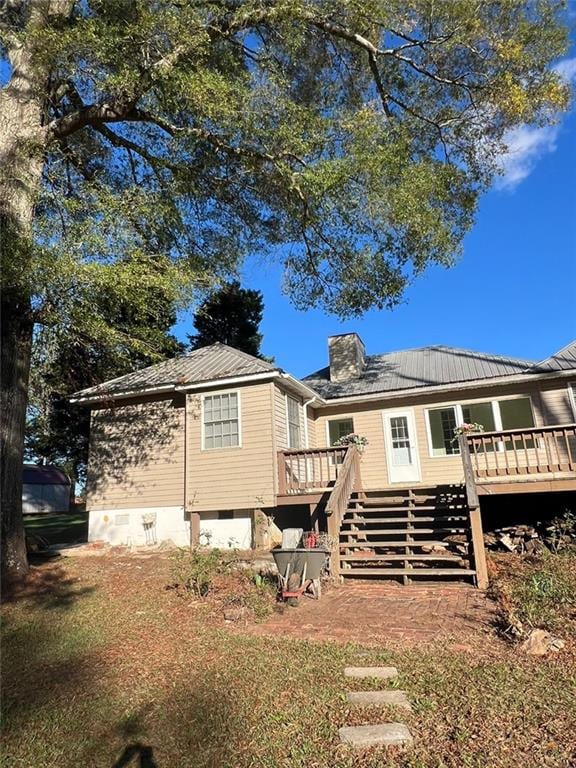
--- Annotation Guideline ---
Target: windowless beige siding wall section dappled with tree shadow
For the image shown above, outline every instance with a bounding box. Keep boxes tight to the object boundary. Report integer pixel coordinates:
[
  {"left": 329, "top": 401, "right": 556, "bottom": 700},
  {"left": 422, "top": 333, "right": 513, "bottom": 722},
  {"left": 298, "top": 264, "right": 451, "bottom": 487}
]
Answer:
[{"left": 86, "top": 396, "right": 184, "bottom": 510}]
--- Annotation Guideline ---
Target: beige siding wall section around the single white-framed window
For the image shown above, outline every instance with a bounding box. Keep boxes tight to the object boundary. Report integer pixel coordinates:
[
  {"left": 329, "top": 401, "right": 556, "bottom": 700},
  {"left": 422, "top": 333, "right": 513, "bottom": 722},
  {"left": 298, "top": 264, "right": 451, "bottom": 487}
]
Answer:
[{"left": 187, "top": 383, "right": 274, "bottom": 512}]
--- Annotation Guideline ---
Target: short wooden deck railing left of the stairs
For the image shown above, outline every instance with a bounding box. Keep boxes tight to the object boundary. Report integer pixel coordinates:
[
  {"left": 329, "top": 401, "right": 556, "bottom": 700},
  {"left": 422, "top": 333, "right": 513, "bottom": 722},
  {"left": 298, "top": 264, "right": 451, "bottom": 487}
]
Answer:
[{"left": 278, "top": 446, "right": 347, "bottom": 496}]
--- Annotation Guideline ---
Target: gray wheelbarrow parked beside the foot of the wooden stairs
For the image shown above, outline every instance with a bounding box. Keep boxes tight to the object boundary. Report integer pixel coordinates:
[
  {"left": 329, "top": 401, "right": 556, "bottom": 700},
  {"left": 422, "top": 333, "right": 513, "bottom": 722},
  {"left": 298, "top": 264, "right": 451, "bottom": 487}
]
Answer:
[{"left": 272, "top": 548, "right": 328, "bottom": 605}]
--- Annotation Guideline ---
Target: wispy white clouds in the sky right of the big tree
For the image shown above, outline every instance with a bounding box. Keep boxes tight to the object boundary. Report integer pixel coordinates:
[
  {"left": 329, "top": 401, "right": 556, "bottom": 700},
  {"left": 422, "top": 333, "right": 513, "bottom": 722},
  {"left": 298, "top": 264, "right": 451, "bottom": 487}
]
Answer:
[{"left": 495, "top": 58, "right": 576, "bottom": 190}]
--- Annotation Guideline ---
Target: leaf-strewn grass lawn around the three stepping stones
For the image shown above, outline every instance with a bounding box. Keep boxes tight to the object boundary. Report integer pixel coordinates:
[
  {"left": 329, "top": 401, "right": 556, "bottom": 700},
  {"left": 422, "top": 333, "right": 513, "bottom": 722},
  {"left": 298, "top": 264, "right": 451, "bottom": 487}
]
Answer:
[{"left": 0, "top": 555, "right": 576, "bottom": 768}]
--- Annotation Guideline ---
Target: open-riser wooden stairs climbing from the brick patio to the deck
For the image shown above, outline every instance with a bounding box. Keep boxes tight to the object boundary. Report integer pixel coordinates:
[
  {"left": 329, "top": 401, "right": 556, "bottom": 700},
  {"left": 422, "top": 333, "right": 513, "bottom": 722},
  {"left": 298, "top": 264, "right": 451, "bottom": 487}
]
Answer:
[{"left": 338, "top": 486, "right": 477, "bottom": 584}]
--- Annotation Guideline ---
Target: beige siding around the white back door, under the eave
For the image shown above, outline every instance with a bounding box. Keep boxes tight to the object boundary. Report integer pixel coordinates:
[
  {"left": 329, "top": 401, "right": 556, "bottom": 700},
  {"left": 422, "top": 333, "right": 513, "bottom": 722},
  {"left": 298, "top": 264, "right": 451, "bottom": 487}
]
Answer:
[{"left": 315, "top": 382, "right": 572, "bottom": 490}]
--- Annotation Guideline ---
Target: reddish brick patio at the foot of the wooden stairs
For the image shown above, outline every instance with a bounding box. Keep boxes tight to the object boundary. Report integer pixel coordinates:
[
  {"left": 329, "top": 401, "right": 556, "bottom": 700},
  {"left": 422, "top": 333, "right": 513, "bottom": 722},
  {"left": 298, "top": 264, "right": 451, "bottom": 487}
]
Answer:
[{"left": 243, "top": 582, "right": 492, "bottom": 649}]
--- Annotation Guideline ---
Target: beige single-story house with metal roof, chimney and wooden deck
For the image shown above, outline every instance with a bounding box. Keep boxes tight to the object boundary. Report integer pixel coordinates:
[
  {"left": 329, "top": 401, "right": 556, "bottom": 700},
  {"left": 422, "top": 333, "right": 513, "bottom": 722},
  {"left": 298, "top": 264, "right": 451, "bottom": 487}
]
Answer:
[{"left": 74, "top": 333, "right": 576, "bottom": 585}]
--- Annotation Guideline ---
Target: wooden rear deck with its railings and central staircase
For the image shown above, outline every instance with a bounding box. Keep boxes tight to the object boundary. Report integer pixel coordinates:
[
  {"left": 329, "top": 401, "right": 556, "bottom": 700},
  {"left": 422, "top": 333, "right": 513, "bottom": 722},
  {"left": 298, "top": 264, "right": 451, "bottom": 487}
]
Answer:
[{"left": 277, "top": 424, "right": 576, "bottom": 588}]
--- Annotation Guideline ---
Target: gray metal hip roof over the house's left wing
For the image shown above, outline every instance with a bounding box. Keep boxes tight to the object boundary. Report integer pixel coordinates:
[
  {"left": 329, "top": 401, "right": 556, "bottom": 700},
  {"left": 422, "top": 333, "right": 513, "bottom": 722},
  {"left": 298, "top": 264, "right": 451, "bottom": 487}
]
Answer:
[{"left": 74, "top": 342, "right": 279, "bottom": 398}]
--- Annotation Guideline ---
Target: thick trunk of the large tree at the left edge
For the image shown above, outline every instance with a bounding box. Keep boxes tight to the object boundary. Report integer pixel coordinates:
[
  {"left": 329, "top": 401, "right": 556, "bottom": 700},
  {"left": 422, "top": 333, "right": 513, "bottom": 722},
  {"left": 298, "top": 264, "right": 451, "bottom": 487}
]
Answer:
[{"left": 0, "top": 0, "right": 49, "bottom": 581}]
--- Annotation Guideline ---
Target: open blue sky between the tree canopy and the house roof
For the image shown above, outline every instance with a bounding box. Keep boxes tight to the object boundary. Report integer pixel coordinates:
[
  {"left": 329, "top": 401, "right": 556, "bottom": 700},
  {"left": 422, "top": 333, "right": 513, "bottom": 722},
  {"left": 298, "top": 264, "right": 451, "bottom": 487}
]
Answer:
[{"left": 176, "top": 59, "right": 576, "bottom": 376}]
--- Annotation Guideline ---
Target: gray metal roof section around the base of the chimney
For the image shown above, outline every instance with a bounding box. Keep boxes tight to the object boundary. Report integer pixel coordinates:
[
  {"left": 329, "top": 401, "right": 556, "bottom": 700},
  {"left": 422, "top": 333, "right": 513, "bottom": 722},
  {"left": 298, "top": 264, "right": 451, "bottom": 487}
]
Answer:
[{"left": 302, "top": 346, "right": 533, "bottom": 399}]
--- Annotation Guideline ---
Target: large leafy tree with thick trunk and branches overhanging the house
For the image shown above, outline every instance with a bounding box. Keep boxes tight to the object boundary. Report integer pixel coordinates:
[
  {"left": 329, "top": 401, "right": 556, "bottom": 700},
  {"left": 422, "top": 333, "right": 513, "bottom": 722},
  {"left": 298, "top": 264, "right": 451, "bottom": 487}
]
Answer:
[{"left": 0, "top": 0, "right": 567, "bottom": 576}]
